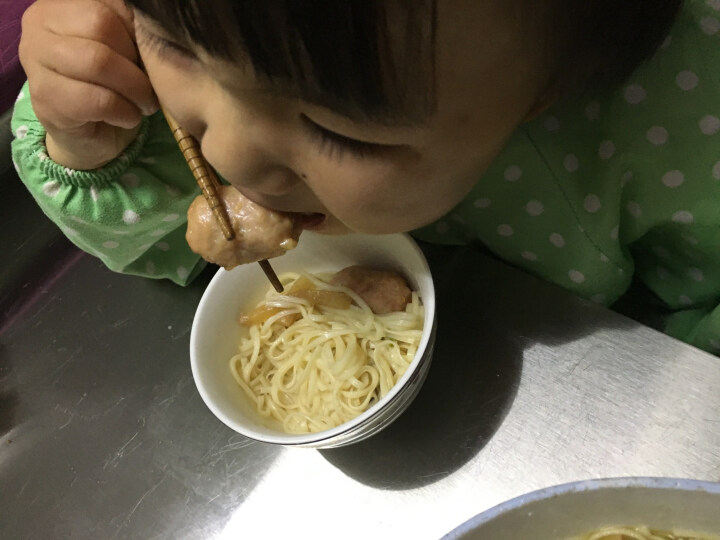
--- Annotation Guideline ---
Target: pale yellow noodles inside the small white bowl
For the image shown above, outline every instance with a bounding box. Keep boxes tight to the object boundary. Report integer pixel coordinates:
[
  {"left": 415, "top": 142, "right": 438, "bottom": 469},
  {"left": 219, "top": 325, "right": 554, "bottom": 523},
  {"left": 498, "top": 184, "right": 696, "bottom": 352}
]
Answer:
[{"left": 230, "top": 273, "right": 424, "bottom": 433}]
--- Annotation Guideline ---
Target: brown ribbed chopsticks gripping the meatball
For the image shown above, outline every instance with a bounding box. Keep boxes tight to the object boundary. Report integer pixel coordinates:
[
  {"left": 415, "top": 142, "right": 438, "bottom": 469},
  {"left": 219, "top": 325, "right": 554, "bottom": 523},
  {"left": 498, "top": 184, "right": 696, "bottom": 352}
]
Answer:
[{"left": 163, "top": 111, "right": 283, "bottom": 293}]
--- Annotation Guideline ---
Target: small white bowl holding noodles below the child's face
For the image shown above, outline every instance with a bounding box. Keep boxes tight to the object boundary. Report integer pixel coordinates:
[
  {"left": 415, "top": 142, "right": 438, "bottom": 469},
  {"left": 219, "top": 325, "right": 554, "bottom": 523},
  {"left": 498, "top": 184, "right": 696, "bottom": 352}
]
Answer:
[{"left": 190, "top": 232, "right": 435, "bottom": 448}]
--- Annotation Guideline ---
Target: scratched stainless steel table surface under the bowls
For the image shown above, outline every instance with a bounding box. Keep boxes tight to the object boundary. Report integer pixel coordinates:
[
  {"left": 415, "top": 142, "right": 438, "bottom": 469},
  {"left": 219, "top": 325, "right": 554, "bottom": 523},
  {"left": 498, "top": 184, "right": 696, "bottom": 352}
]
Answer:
[{"left": 0, "top": 167, "right": 720, "bottom": 539}]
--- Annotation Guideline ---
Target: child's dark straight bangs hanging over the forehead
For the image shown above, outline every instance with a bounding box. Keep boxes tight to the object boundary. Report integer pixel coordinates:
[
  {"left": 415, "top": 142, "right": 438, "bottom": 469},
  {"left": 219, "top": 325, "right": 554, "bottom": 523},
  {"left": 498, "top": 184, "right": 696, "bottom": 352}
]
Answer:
[{"left": 127, "top": 0, "right": 436, "bottom": 124}]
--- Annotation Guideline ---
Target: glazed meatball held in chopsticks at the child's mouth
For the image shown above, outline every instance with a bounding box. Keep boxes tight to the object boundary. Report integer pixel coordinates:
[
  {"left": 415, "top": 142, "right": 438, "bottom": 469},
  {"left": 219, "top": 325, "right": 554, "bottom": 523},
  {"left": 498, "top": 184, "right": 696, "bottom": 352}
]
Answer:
[{"left": 185, "top": 186, "right": 302, "bottom": 270}]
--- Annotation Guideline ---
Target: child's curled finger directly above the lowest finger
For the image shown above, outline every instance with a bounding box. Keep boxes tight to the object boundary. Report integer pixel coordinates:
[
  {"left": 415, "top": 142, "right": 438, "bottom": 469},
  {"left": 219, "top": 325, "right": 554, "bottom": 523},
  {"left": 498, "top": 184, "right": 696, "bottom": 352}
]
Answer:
[{"left": 42, "top": 33, "right": 157, "bottom": 114}]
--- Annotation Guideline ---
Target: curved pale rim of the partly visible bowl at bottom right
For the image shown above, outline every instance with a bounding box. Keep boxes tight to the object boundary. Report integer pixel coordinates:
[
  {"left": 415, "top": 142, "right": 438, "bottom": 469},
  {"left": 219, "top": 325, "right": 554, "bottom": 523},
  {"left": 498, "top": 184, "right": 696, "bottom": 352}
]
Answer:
[{"left": 441, "top": 476, "right": 720, "bottom": 540}]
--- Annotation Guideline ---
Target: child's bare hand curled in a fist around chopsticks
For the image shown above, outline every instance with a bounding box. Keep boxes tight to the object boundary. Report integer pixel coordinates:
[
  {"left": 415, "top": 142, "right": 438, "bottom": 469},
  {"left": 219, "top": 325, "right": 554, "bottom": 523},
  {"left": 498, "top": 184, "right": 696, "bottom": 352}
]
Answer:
[{"left": 20, "top": 0, "right": 157, "bottom": 169}]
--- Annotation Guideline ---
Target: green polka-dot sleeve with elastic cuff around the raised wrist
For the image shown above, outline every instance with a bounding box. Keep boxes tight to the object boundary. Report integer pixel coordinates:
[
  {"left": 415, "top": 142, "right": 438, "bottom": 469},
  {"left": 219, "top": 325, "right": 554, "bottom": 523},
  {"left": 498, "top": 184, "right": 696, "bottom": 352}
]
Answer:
[{"left": 11, "top": 83, "right": 204, "bottom": 285}]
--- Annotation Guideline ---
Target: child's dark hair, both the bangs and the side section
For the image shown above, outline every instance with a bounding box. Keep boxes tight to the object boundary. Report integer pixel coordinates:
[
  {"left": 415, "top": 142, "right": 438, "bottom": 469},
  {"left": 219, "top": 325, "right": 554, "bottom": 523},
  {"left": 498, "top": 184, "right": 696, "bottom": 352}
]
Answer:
[{"left": 126, "top": 0, "right": 682, "bottom": 118}]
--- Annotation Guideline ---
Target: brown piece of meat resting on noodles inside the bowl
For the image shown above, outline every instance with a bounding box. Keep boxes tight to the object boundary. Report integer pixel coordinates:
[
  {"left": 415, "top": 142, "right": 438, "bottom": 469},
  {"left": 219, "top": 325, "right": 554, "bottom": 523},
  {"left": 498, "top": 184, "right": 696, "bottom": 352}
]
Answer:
[{"left": 330, "top": 266, "right": 412, "bottom": 314}]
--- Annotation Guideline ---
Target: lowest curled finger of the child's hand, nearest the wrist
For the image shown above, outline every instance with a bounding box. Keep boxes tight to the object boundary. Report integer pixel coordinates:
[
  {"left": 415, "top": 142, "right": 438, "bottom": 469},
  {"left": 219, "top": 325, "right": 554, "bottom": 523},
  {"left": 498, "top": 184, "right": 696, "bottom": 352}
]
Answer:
[{"left": 30, "top": 72, "right": 142, "bottom": 131}]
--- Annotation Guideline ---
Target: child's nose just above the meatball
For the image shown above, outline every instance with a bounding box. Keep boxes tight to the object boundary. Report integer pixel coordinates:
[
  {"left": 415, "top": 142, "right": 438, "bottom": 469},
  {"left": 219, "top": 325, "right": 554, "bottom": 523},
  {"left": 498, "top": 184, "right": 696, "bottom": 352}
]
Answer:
[{"left": 201, "top": 119, "right": 301, "bottom": 196}]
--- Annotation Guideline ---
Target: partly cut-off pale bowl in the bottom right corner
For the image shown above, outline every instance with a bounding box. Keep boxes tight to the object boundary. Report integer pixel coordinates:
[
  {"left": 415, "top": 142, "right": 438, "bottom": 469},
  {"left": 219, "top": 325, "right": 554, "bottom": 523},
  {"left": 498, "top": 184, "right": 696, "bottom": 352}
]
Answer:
[{"left": 443, "top": 477, "right": 720, "bottom": 540}]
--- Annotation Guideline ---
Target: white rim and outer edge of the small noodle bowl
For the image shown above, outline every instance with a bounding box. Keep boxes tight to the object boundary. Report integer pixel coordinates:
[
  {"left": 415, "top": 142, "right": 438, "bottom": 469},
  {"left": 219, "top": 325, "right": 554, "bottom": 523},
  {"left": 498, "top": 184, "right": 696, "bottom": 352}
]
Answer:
[{"left": 190, "top": 233, "right": 437, "bottom": 448}]
